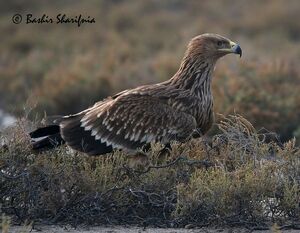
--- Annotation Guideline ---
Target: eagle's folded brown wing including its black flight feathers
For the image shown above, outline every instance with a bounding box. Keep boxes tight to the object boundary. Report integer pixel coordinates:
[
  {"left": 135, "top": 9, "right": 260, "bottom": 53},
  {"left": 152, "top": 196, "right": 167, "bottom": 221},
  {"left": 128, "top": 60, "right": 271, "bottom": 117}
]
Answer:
[{"left": 61, "top": 93, "right": 196, "bottom": 155}]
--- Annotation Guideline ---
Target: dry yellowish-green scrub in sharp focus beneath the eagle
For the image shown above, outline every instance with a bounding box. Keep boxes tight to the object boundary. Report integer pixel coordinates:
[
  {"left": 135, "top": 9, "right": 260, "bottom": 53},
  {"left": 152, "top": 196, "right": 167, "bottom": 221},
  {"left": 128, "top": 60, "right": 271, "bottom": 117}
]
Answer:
[{"left": 0, "top": 115, "right": 300, "bottom": 228}]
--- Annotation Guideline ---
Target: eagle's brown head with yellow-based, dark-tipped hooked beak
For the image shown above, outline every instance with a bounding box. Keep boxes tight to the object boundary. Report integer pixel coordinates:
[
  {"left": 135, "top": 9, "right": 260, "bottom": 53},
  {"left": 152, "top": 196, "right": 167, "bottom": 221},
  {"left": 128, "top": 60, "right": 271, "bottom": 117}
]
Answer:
[{"left": 186, "top": 33, "right": 242, "bottom": 61}]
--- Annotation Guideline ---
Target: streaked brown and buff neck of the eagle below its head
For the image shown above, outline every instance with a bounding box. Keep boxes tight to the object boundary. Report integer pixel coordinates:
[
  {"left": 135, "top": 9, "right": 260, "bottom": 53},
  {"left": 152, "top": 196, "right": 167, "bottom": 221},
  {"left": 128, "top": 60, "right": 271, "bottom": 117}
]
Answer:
[{"left": 169, "top": 56, "right": 215, "bottom": 97}]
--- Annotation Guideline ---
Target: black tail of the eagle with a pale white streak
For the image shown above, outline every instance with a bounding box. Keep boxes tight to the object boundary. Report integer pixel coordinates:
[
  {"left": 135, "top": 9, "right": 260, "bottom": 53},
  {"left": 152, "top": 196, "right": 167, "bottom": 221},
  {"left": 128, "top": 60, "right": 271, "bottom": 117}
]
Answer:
[{"left": 29, "top": 125, "right": 65, "bottom": 150}]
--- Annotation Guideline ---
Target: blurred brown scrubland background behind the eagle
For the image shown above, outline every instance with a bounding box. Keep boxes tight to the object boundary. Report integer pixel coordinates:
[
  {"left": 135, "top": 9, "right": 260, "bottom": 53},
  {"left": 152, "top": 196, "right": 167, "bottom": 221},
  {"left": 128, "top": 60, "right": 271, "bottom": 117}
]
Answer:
[{"left": 0, "top": 0, "right": 300, "bottom": 140}]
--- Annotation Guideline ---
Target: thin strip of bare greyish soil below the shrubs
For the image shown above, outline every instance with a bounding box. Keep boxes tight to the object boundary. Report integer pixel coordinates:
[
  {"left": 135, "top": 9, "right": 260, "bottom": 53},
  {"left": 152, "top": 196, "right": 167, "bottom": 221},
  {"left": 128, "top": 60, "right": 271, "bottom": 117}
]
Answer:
[{"left": 8, "top": 226, "right": 299, "bottom": 233}]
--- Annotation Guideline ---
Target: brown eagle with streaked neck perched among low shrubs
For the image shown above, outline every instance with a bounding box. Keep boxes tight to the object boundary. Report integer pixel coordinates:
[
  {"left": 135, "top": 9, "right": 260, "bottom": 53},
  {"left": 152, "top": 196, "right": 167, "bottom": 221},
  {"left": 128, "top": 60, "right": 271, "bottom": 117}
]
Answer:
[{"left": 30, "top": 33, "right": 242, "bottom": 156}]
